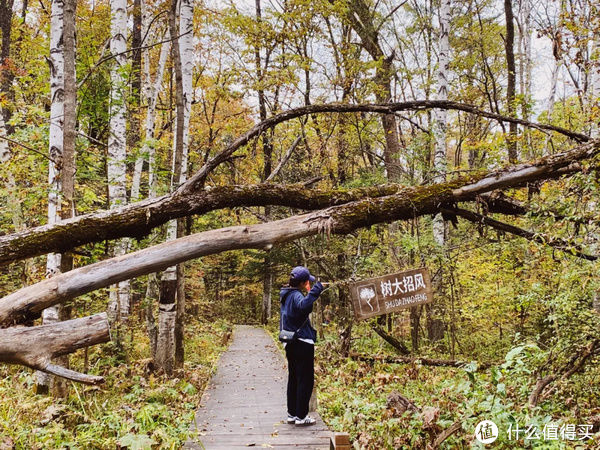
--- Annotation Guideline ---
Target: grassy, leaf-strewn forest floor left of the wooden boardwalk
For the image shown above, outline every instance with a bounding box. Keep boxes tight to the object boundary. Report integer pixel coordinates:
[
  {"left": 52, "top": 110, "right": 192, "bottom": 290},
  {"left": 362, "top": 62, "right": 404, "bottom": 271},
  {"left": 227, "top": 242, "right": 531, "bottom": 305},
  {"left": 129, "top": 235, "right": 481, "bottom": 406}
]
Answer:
[{"left": 0, "top": 314, "right": 231, "bottom": 450}]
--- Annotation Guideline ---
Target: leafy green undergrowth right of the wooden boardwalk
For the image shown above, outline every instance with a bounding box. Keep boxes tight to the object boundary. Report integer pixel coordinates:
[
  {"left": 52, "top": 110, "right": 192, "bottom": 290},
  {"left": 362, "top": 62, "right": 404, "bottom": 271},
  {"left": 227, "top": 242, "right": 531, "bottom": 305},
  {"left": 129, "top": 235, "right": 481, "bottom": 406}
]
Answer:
[{"left": 270, "top": 322, "right": 600, "bottom": 450}]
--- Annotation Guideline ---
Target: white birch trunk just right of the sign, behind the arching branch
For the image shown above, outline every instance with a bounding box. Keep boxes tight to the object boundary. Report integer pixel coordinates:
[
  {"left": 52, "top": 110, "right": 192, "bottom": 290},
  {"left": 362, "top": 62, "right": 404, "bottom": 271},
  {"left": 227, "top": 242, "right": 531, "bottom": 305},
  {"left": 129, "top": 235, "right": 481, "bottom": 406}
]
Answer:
[{"left": 433, "top": 0, "right": 450, "bottom": 245}]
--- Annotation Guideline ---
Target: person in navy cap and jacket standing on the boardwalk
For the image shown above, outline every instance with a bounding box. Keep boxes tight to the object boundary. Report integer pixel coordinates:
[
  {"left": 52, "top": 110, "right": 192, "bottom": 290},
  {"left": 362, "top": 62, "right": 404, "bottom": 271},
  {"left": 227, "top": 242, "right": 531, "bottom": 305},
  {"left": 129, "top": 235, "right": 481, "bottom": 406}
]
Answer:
[{"left": 279, "top": 266, "right": 323, "bottom": 426}]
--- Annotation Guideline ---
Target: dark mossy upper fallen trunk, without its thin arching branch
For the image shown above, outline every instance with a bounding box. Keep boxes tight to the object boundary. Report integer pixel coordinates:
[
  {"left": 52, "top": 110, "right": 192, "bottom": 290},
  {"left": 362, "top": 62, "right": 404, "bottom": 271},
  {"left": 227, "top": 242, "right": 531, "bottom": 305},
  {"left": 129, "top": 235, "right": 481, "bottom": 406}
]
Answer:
[{"left": 0, "top": 184, "right": 403, "bottom": 265}]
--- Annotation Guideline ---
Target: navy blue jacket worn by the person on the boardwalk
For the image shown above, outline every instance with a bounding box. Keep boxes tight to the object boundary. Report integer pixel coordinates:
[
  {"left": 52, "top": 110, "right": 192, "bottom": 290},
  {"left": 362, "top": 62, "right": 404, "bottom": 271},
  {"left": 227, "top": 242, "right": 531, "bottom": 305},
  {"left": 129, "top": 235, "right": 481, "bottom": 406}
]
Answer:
[{"left": 279, "top": 281, "right": 323, "bottom": 342}]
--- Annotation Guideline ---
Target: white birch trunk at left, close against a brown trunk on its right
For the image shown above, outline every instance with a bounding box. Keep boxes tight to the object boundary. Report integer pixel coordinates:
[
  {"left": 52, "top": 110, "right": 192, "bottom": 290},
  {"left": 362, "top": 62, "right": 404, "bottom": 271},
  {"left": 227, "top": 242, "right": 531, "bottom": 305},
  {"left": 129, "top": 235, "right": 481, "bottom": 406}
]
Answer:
[{"left": 37, "top": 0, "right": 65, "bottom": 392}]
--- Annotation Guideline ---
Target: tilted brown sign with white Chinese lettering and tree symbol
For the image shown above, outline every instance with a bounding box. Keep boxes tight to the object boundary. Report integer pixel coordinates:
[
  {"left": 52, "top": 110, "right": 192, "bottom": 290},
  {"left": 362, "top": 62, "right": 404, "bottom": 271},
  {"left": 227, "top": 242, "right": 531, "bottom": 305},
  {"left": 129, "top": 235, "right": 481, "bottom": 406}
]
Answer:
[{"left": 349, "top": 269, "right": 433, "bottom": 320}]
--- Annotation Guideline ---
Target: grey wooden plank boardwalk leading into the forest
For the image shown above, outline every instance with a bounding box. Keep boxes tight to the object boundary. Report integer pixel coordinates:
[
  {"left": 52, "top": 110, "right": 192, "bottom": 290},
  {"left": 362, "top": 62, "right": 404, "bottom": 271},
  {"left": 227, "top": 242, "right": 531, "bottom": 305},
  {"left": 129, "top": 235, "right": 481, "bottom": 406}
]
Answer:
[{"left": 184, "top": 325, "right": 332, "bottom": 450}]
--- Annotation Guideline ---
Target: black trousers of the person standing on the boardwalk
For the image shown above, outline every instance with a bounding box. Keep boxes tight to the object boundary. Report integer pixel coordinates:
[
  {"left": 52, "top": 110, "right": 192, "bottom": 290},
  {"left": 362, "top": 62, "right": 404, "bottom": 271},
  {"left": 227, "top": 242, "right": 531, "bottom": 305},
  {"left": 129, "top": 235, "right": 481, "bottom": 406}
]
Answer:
[{"left": 285, "top": 340, "right": 315, "bottom": 419}]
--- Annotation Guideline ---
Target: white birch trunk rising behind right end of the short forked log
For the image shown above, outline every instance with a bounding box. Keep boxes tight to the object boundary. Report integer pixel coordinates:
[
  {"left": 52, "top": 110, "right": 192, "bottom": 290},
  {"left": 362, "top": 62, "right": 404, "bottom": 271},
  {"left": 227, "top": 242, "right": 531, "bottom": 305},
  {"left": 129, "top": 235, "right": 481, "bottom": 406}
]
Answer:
[{"left": 107, "top": 0, "right": 129, "bottom": 319}]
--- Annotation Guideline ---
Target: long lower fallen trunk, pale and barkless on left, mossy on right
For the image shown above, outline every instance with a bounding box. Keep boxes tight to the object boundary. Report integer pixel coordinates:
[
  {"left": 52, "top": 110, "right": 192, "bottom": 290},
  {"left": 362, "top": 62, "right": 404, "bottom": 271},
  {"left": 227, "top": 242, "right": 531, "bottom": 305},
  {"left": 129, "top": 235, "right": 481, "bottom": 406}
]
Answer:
[{"left": 0, "top": 140, "right": 600, "bottom": 325}]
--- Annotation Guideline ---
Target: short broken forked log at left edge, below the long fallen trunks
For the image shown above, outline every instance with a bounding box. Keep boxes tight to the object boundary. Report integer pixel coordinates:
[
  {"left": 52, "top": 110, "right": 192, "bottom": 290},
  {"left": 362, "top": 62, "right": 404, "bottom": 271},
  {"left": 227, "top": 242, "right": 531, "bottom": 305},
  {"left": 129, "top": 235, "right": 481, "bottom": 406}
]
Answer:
[{"left": 0, "top": 313, "right": 110, "bottom": 384}]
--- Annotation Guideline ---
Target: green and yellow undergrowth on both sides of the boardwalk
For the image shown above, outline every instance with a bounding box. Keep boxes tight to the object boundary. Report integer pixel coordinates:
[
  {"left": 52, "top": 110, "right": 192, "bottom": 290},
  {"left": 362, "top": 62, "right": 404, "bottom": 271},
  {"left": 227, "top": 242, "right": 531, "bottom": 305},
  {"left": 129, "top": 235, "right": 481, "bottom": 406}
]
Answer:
[{"left": 0, "top": 314, "right": 600, "bottom": 450}]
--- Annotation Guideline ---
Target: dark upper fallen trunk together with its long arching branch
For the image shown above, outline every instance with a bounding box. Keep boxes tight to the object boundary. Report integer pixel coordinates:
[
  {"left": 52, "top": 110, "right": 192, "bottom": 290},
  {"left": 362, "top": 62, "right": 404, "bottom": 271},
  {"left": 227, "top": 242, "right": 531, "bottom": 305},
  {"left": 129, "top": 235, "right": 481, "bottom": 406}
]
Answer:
[{"left": 0, "top": 101, "right": 590, "bottom": 265}]
